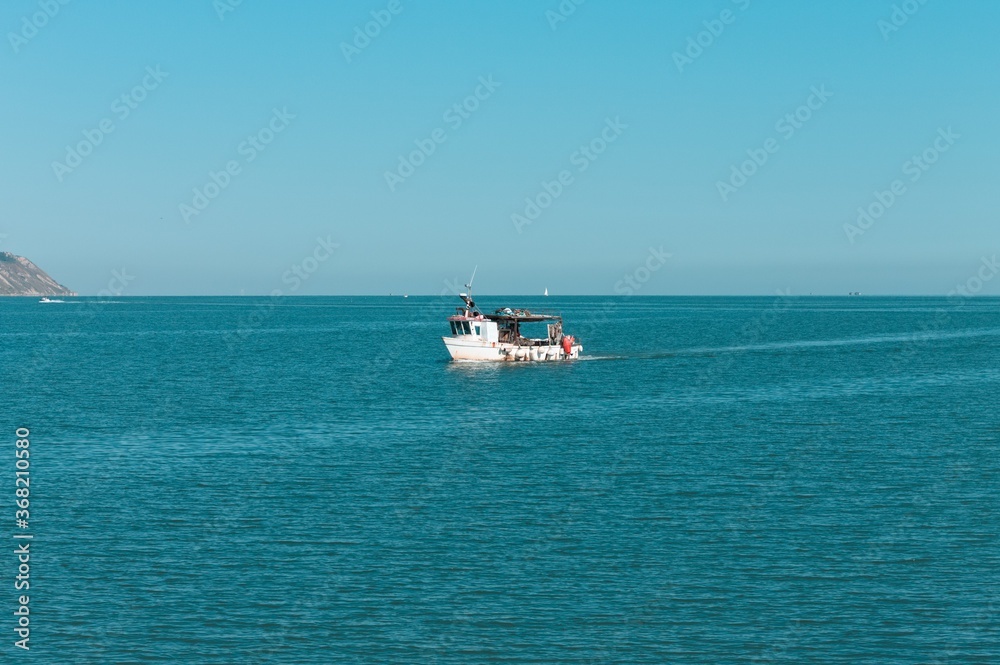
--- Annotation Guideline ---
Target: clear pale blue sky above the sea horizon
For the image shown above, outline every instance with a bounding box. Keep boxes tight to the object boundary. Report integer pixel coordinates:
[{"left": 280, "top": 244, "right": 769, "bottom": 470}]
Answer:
[{"left": 0, "top": 0, "right": 1000, "bottom": 295}]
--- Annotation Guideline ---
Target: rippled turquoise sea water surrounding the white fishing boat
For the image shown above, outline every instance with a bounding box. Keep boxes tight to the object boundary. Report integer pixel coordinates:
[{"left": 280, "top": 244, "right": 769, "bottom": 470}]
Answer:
[{"left": 0, "top": 296, "right": 1000, "bottom": 663}]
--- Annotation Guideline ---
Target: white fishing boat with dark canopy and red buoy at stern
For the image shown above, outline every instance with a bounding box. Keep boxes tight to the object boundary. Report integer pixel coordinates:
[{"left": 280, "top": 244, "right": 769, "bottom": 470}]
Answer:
[{"left": 441, "top": 272, "right": 583, "bottom": 362}]
